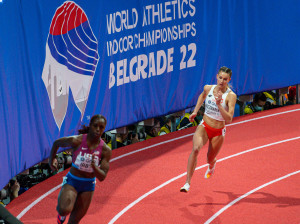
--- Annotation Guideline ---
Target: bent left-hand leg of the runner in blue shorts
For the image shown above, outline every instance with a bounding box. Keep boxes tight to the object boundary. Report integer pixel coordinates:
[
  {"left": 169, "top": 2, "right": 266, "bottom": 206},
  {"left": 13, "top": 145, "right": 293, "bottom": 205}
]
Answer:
[{"left": 56, "top": 184, "right": 77, "bottom": 216}]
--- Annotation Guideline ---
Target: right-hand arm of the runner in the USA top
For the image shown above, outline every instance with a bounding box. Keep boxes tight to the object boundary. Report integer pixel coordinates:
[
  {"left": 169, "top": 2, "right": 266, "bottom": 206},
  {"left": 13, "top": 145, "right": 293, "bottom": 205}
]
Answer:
[{"left": 91, "top": 143, "right": 111, "bottom": 181}]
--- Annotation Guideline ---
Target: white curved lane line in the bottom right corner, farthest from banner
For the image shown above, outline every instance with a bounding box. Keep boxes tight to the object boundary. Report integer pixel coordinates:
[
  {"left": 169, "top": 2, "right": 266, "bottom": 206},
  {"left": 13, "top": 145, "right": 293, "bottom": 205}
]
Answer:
[{"left": 204, "top": 170, "right": 300, "bottom": 224}]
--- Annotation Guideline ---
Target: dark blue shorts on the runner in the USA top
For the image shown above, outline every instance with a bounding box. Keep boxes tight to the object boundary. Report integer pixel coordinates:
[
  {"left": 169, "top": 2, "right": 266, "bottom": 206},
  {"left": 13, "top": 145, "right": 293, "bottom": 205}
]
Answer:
[{"left": 63, "top": 172, "right": 96, "bottom": 193}]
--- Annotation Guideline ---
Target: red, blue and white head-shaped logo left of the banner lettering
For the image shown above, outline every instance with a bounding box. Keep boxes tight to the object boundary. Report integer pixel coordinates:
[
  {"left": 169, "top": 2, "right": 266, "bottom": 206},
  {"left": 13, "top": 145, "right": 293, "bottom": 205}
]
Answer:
[{"left": 42, "top": 1, "right": 99, "bottom": 129}]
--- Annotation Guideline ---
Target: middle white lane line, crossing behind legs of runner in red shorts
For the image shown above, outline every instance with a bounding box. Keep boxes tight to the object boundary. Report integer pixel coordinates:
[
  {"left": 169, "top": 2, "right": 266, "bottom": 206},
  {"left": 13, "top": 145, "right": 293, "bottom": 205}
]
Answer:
[{"left": 109, "top": 136, "right": 300, "bottom": 224}]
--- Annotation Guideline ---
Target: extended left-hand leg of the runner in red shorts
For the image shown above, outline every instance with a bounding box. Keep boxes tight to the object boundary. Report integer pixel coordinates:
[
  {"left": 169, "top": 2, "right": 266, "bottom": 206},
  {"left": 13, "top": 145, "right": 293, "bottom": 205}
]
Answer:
[{"left": 186, "top": 125, "right": 208, "bottom": 184}]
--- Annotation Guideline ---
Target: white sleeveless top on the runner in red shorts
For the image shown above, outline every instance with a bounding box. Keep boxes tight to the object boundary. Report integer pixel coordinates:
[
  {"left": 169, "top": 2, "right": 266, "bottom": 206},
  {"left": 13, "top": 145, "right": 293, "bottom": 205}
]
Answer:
[{"left": 204, "top": 85, "right": 231, "bottom": 121}]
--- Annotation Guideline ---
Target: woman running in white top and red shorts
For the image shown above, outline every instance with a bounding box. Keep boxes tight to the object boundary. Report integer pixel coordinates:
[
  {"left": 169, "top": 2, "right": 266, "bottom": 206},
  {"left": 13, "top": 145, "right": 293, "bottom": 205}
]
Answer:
[{"left": 180, "top": 67, "right": 237, "bottom": 192}]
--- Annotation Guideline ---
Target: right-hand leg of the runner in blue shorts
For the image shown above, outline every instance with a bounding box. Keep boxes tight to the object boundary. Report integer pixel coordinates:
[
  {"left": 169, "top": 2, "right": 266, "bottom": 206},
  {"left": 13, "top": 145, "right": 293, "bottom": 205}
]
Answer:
[{"left": 68, "top": 191, "right": 94, "bottom": 224}]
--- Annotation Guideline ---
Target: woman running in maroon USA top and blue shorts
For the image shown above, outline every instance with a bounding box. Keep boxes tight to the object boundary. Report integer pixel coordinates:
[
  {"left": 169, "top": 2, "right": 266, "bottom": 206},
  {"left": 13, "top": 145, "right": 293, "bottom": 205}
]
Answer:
[{"left": 49, "top": 115, "right": 111, "bottom": 224}]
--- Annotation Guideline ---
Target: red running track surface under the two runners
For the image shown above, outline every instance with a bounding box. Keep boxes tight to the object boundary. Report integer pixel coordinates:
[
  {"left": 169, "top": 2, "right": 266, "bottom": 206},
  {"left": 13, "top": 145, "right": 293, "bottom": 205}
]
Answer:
[{"left": 7, "top": 105, "right": 300, "bottom": 224}]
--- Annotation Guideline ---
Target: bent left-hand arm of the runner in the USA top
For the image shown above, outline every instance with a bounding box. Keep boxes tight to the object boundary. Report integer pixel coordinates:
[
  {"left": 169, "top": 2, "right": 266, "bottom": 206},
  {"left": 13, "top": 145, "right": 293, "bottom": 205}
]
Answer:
[{"left": 49, "top": 135, "right": 82, "bottom": 170}]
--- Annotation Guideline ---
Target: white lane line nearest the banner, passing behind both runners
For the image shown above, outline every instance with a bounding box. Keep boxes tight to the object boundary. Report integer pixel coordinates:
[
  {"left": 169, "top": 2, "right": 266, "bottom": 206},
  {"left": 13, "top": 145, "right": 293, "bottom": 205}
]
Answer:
[{"left": 18, "top": 109, "right": 300, "bottom": 218}]
